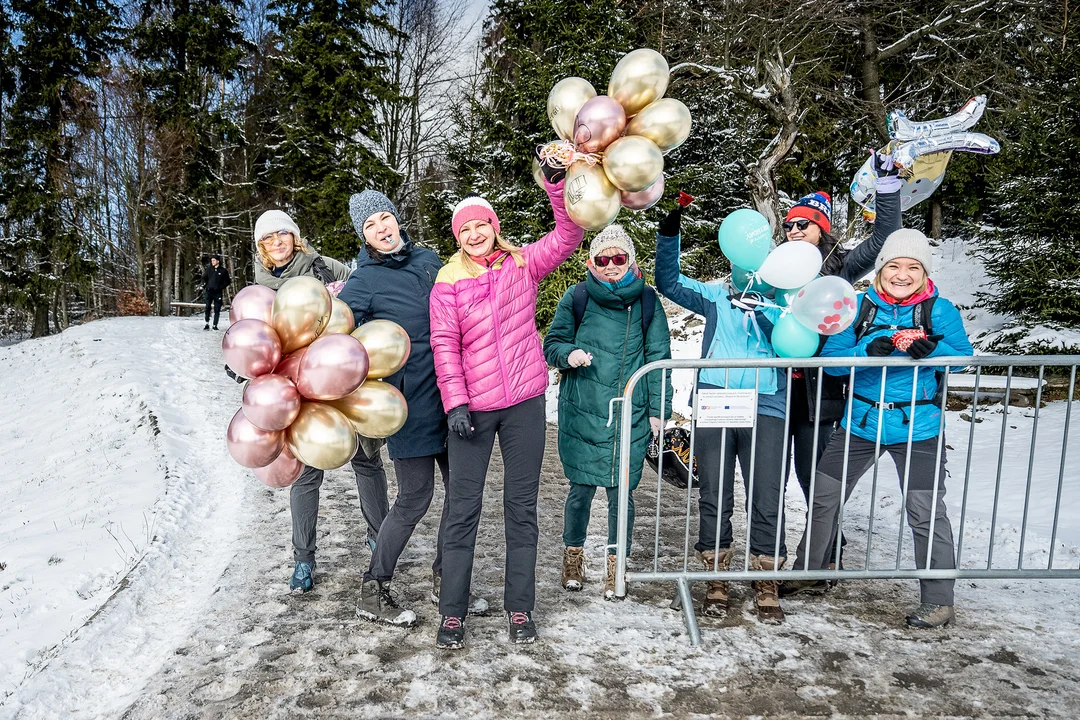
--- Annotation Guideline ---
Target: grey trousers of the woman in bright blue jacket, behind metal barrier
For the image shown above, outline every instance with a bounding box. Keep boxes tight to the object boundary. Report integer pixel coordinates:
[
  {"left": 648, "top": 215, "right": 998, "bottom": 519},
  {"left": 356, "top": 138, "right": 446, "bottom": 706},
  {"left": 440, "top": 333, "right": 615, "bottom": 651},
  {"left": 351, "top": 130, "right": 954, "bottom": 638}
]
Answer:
[{"left": 795, "top": 430, "right": 956, "bottom": 604}]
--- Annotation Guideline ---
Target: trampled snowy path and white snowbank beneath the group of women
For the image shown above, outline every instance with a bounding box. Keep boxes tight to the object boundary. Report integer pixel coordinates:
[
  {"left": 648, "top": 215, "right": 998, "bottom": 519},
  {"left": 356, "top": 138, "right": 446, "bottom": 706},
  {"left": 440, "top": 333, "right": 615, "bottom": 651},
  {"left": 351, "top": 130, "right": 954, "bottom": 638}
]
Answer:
[{"left": 0, "top": 318, "right": 1080, "bottom": 719}]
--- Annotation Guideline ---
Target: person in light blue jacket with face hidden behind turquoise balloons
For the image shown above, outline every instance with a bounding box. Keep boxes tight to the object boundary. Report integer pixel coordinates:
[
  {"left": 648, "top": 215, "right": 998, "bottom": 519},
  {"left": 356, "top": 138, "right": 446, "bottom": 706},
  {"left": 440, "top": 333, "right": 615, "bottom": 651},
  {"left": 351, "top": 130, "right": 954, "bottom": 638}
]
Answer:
[{"left": 656, "top": 207, "right": 787, "bottom": 624}]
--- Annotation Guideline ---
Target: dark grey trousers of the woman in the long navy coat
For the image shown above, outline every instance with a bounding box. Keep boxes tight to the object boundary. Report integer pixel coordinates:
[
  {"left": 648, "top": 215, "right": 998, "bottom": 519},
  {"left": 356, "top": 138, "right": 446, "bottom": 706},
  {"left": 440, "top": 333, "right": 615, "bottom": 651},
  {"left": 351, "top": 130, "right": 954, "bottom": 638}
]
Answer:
[{"left": 364, "top": 451, "right": 450, "bottom": 580}]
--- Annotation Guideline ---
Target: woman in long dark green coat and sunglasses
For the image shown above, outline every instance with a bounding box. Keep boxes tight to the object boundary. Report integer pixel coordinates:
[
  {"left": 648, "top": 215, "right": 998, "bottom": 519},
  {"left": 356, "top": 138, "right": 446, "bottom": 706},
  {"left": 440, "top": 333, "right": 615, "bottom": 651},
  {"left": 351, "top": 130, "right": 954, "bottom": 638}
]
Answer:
[{"left": 543, "top": 225, "right": 671, "bottom": 600}]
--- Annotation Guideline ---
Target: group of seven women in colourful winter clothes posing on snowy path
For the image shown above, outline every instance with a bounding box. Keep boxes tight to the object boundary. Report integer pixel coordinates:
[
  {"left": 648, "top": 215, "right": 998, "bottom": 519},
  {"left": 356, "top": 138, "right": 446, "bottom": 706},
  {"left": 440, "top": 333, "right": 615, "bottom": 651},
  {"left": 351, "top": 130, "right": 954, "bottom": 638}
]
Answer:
[{"left": 223, "top": 144, "right": 971, "bottom": 649}]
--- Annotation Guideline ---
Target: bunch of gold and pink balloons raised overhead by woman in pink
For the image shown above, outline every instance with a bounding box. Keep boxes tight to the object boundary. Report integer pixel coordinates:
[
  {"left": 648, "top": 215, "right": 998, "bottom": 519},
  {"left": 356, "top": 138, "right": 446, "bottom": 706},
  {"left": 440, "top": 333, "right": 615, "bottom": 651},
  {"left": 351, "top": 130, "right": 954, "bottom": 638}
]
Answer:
[{"left": 532, "top": 49, "right": 690, "bottom": 230}]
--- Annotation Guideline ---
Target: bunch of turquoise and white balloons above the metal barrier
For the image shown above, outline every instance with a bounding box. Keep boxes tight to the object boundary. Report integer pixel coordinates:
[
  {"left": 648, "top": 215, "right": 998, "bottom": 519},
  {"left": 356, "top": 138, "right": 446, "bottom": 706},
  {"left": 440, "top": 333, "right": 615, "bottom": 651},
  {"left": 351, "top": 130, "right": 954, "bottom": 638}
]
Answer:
[{"left": 718, "top": 208, "right": 859, "bottom": 357}]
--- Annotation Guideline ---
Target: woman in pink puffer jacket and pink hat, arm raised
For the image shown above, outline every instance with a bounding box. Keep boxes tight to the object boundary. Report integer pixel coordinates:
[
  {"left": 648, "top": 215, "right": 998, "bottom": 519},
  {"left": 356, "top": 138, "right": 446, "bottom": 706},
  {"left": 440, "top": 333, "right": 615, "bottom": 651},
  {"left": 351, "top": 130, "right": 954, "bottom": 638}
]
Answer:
[{"left": 431, "top": 165, "right": 584, "bottom": 648}]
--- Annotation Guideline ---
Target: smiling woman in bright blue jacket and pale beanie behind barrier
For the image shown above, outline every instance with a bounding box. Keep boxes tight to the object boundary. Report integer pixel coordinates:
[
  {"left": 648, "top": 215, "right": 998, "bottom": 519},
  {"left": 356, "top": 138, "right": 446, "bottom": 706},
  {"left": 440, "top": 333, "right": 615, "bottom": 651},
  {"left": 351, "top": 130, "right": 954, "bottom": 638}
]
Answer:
[{"left": 781, "top": 229, "right": 972, "bottom": 627}]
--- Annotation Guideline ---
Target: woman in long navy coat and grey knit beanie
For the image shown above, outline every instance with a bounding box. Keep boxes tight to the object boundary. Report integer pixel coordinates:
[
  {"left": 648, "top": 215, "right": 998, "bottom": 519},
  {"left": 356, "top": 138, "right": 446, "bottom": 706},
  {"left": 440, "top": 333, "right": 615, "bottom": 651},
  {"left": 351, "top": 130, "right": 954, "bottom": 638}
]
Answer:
[{"left": 338, "top": 190, "right": 487, "bottom": 627}]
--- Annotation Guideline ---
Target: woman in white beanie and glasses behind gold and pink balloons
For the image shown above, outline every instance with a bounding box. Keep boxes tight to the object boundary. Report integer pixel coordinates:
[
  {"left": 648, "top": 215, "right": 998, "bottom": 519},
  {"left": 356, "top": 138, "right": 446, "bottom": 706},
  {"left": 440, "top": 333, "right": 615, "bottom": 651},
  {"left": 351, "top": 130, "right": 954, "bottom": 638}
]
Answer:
[{"left": 255, "top": 210, "right": 387, "bottom": 593}]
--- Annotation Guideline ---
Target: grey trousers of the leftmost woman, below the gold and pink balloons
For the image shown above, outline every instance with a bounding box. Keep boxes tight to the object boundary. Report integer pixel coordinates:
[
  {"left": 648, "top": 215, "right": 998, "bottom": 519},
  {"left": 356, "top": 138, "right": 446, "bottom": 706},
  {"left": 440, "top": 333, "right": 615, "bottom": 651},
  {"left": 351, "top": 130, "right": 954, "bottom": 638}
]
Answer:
[{"left": 288, "top": 441, "right": 388, "bottom": 562}]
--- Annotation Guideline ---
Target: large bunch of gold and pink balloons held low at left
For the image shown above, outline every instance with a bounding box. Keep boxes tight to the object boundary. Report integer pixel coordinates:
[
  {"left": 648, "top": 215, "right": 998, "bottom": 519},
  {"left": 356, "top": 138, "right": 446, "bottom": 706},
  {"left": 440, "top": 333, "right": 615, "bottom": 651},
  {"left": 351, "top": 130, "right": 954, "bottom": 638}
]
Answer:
[{"left": 221, "top": 277, "right": 411, "bottom": 488}]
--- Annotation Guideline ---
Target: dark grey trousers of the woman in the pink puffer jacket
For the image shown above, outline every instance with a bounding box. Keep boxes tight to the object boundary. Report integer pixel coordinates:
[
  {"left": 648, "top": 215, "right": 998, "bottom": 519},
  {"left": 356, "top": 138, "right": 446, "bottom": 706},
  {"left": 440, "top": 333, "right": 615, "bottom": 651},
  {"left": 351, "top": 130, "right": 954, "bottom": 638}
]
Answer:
[{"left": 438, "top": 395, "right": 545, "bottom": 617}]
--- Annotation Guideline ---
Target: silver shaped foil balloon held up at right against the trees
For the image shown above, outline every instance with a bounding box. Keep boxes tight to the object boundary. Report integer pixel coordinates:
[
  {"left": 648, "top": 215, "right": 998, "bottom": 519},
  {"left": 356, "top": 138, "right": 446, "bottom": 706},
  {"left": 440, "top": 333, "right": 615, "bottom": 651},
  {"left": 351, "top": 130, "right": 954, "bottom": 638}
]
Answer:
[{"left": 851, "top": 95, "right": 1001, "bottom": 220}]
